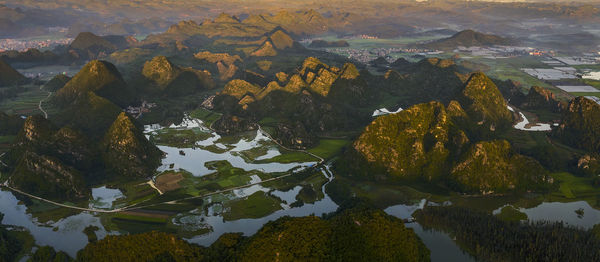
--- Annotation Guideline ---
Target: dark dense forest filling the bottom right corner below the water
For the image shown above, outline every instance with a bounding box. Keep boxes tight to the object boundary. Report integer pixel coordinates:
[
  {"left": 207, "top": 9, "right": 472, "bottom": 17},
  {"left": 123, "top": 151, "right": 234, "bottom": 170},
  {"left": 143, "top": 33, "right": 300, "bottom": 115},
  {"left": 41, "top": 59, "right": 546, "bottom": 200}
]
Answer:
[{"left": 415, "top": 206, "right": 600, "bottom": 261}]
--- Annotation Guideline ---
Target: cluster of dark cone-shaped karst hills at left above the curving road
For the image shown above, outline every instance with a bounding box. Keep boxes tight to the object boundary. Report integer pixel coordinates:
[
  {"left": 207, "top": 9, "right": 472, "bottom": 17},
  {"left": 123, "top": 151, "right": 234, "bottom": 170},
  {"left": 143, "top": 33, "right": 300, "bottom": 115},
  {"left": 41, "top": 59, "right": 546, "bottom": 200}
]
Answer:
[{"left": 4, "top": 61, "right": 161, "bottom": 200}]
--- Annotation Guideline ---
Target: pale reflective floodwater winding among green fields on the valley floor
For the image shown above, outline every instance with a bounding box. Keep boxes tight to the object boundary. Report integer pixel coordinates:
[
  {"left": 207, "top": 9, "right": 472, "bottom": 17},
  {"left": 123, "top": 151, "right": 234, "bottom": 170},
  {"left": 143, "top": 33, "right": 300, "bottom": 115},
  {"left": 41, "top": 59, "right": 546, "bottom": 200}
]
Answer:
[{"left": 0, "top": 115, "right": 600, "bottom": 261}]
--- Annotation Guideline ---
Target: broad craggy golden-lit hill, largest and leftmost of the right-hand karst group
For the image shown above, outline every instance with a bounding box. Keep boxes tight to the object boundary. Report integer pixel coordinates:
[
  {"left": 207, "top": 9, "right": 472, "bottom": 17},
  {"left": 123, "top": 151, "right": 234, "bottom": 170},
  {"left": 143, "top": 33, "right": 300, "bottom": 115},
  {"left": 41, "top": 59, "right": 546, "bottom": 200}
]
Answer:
[{"left": 352, "top": 102, "right": 469, "bottom": 180}]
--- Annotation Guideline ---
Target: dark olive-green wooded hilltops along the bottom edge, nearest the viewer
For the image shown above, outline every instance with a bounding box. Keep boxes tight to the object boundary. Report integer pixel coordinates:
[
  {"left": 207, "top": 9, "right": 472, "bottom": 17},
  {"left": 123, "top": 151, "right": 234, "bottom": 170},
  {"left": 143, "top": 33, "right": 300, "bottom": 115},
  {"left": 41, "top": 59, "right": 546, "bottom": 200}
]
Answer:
[{"left": 77, "top": 208, "right": 429, "bottom": 261}]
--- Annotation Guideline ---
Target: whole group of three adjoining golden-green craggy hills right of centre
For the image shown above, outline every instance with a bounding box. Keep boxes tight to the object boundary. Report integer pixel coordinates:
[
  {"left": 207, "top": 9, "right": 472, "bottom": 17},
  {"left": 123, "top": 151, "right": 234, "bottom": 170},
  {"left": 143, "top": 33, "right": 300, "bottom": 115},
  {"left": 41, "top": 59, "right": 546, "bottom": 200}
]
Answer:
[{"left": 336, "top": 69, "right": 551, "bottom": 194}]
